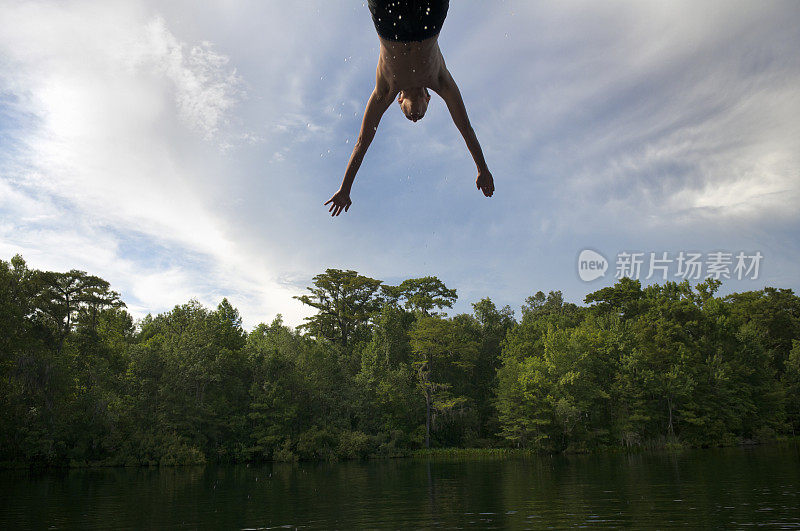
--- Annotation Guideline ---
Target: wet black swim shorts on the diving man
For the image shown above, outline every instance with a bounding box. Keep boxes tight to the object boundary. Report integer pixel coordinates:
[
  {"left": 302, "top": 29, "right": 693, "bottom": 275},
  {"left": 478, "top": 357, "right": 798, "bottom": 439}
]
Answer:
[{"left": 369, "top": 0, "right": 450, "bottom": 42}]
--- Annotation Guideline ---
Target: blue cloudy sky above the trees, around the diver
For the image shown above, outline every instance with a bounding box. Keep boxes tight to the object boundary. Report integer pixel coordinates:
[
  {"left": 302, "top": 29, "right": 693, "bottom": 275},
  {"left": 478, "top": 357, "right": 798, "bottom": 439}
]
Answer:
[{"left": 0, "top": 0, "right": 800, "bottom": 328}]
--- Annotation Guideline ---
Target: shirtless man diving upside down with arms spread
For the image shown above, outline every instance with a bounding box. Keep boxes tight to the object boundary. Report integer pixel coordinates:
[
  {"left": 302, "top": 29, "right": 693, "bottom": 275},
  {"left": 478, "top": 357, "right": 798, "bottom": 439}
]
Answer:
[{"left": 325, "top": 0, "right": 494, "bottom": 216}]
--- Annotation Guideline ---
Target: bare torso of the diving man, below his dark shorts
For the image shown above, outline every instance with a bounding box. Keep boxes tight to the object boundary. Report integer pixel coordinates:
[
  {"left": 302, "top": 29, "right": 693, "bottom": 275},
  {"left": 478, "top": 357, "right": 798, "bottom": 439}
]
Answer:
[{"left": 376, "top": 36, "right": 445, "bottom": 95}]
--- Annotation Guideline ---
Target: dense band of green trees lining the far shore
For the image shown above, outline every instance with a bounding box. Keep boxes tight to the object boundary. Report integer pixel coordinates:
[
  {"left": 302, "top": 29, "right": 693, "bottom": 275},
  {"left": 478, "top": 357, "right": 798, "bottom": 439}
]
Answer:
[{"left": 0, "top": 256, "right": 800, "bottom": 465}]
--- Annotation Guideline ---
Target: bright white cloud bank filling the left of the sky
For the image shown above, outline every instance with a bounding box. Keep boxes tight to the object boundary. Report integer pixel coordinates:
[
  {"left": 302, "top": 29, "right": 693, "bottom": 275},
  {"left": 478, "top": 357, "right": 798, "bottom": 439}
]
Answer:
[{"left": 0, "top": 2, "right": 310, "bottom": 324}]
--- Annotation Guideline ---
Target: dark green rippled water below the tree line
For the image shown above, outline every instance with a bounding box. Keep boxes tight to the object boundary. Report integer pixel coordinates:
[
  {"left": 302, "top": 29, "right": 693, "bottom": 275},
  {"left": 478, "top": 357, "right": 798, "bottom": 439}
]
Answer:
[{"left": 0, "top": 445, "right": 800, "bottom": 529}]
